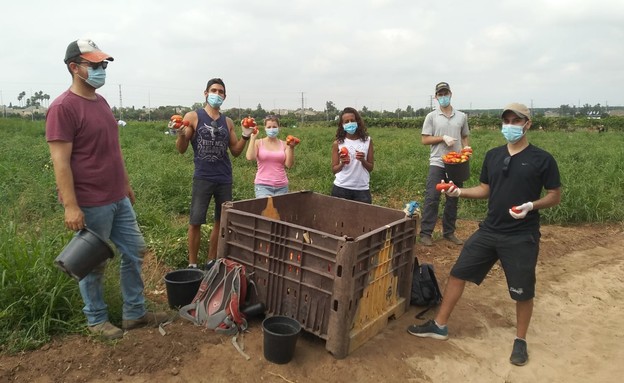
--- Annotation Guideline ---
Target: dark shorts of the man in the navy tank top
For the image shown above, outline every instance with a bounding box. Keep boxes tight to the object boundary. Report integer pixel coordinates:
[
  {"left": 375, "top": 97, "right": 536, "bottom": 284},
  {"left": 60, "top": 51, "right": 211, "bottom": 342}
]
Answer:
[{"left": 189, "top": 178, "right": 232, "bottom": 225}]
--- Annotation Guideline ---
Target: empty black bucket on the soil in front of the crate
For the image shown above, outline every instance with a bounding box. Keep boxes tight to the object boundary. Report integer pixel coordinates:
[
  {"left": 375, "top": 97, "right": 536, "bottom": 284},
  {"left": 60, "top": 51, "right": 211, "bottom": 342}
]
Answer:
[{"left": 262, "top": 315, "right": 301, "bottom": 364}]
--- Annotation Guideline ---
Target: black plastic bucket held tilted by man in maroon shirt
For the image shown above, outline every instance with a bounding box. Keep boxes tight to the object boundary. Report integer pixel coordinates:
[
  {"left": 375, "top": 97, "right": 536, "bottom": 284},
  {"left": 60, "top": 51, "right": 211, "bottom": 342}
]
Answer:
[{"left": 54, "top": 228, "right": 115, "bottom": 281}]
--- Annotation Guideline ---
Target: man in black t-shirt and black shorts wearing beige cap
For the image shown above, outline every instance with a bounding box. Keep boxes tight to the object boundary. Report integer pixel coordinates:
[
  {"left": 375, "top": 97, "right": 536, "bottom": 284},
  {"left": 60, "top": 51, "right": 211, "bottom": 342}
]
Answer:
[{"left": 407, "top": 103, "right": 561, "bottom": 366}]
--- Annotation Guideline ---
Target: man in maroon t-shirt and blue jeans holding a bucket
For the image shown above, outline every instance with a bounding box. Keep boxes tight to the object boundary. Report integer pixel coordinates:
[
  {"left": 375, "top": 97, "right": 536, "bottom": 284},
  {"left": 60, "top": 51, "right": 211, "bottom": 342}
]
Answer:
[{"left": 46, "top": 39, "right": 168, "bottom": 339}]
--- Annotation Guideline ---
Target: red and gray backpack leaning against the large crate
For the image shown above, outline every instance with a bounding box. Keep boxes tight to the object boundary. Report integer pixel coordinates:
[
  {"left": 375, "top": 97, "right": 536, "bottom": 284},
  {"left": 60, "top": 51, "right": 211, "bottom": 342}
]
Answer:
[{"left": 180, "top": 258, "right": 247, "bottom": 335}]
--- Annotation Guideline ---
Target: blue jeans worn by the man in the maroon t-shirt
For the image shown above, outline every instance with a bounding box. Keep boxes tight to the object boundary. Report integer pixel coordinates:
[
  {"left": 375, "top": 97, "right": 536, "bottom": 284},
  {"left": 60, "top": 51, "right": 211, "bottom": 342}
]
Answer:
[{"left": 79, "top": 198, "right": 145, "bottom": 326}]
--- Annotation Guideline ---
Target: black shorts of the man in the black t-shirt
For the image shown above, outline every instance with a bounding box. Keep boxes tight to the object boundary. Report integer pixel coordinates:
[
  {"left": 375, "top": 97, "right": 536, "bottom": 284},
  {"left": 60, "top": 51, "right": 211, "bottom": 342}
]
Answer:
[{"left": 451, "top": 229, "right": 540, "bottom": 301}]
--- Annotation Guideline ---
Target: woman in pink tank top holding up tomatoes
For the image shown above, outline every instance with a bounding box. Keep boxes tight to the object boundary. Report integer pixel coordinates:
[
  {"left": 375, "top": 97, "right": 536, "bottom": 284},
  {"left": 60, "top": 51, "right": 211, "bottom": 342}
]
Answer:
[{"left": 246, "top": 115, "right": 297, "bottom": 198}]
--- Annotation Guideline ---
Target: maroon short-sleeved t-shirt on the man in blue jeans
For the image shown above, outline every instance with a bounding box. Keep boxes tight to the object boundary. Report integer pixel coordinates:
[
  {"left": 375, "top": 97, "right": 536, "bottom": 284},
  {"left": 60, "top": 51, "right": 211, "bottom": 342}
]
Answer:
[{"left": 46, "top": 90, "right": 127, "bottom": 207}]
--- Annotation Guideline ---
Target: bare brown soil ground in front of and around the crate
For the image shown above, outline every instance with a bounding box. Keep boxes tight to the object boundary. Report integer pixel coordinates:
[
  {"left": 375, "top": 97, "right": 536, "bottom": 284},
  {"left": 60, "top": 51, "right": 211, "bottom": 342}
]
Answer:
[{"left": 0, "top": 221, "right": 624, "bottom": 383}]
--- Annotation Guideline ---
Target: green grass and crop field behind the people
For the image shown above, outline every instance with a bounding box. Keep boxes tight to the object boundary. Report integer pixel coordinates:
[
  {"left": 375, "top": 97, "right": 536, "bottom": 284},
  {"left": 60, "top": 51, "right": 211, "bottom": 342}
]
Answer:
[{"left": 0, "top": 119, "right": 624, "bottom": 352}]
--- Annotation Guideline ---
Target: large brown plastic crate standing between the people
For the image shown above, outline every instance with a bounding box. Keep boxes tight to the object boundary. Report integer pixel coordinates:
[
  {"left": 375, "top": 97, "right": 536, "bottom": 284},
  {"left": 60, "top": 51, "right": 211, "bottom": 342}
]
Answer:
[{"left": 218, "top": 191, "right": 417, "bottom": 358}]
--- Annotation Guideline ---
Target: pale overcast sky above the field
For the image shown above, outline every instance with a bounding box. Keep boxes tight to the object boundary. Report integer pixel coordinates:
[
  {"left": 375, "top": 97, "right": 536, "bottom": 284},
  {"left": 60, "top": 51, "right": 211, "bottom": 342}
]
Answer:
[{"left": 0, "top": 0, "right": 624, "bottom": 111}]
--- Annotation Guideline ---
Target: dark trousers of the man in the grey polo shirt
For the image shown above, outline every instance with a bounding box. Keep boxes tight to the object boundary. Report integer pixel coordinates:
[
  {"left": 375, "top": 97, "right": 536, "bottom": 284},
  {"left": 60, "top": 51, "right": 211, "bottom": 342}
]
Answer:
[{"left": 420, "top": 165, "right": 464, "bottom": 237}]
